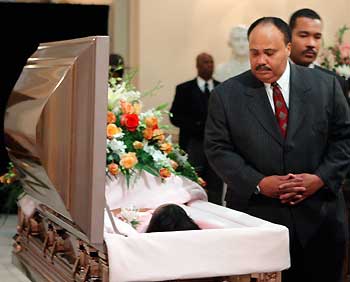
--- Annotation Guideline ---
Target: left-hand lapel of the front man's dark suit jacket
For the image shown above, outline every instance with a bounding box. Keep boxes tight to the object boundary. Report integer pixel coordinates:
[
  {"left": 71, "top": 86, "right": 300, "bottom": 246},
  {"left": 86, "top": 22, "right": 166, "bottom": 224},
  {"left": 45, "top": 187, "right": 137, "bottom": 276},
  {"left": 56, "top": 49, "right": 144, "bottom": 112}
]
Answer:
[{"left": 246, "top": 77, "right": 283, "bottom": 145}]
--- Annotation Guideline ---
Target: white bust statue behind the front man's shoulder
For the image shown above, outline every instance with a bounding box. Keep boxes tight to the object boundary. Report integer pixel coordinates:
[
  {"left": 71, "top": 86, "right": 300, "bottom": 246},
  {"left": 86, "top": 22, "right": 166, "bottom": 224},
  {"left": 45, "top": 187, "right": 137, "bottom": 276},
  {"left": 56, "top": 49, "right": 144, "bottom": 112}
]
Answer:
[{"left": 214, "top": 25, "right": 250, "bottom": 82}]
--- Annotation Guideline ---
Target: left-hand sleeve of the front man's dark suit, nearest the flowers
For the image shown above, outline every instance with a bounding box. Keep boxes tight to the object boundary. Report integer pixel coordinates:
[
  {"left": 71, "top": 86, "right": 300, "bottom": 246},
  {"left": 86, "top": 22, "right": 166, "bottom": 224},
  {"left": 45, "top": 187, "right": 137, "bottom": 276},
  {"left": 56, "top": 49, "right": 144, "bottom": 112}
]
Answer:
[{"left": 204, "top": 90, "right": 264, "bottom": 203}]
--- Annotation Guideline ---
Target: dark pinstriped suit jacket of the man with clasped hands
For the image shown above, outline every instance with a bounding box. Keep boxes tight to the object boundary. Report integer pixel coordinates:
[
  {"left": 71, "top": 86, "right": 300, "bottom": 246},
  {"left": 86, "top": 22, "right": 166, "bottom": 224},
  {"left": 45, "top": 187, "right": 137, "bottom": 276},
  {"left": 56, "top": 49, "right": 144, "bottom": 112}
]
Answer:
[{"left": 205, "top": 64, "right": 350, "bottom": 244}]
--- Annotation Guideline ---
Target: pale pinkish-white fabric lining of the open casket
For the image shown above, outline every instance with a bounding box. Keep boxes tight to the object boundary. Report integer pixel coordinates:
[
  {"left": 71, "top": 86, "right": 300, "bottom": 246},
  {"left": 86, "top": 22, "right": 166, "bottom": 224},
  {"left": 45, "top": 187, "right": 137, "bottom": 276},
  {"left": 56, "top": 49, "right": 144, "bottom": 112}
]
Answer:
[{"left": 105, "top": 173, "right": 289, "bottom": 281}]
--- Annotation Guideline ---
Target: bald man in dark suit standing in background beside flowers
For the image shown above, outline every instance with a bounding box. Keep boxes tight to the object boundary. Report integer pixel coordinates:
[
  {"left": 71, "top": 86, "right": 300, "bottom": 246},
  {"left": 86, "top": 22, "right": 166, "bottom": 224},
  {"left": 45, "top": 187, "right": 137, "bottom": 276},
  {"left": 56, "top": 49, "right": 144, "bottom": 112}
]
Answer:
[{"left": 170, "top": 53, "right": 223, "bottom": 205}]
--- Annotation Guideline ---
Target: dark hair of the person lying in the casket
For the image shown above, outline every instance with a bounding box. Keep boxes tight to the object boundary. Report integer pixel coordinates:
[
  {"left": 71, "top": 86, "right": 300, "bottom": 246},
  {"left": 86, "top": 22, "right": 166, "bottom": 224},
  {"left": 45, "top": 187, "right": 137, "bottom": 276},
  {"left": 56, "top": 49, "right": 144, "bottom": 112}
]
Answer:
[{"left": 146, "top": 204, "right": 200, "bottom": 233}]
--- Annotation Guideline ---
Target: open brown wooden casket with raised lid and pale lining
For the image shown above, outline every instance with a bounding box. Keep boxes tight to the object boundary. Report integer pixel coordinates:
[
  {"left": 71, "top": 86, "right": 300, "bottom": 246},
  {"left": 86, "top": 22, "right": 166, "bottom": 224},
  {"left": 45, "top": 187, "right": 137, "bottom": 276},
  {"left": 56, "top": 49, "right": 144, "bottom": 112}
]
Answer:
[{"left": 5, "top": 36, "right": 290, "bottom": 282}]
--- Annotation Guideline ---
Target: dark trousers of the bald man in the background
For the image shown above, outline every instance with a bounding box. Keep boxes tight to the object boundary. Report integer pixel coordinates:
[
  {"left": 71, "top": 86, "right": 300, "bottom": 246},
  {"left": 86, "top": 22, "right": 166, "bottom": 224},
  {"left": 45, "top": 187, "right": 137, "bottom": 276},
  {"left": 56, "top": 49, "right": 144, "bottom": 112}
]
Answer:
[{"left": 186, "top": 138, "right": 224, "bottom": 205}]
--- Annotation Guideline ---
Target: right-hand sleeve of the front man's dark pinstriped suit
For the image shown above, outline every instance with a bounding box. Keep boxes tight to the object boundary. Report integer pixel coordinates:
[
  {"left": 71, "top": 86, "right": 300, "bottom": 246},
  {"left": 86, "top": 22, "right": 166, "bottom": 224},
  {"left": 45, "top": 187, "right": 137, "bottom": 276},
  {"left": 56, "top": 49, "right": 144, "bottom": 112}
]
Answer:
[{"left": 315, "top": 78, "right": 350, "bottom": 194}]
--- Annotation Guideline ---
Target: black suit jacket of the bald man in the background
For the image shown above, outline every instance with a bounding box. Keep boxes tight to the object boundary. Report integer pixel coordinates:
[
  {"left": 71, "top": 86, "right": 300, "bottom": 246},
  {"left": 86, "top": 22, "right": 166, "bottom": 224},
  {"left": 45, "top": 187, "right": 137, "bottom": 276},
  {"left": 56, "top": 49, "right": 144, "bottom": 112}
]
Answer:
[{"left": 170, "top": 78, "right": 219, "bottom": 149}]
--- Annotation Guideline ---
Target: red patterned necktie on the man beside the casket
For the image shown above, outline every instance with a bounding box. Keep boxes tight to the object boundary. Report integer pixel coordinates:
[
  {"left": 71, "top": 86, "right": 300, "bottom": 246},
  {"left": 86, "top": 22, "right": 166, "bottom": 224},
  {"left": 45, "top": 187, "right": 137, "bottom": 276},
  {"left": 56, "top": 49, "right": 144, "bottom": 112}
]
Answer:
[{"left": 271, "top": 82, "right": 288, "bottom": 137}]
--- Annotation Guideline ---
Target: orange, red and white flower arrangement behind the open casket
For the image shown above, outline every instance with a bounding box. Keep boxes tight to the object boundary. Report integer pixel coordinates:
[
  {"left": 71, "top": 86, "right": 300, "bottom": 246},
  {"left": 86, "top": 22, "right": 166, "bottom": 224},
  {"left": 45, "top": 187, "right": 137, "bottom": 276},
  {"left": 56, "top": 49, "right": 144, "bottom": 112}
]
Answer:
[{"left": 106, "top": 70, "right": 205, "bottom": 186}]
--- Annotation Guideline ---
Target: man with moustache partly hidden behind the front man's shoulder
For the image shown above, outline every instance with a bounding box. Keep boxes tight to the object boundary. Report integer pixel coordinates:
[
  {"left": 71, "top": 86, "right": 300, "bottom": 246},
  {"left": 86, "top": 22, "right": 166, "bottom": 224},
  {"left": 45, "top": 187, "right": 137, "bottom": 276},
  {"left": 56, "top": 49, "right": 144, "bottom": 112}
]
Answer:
[{"left": 289, "top": 9, "right": 350, "bottom": 100}]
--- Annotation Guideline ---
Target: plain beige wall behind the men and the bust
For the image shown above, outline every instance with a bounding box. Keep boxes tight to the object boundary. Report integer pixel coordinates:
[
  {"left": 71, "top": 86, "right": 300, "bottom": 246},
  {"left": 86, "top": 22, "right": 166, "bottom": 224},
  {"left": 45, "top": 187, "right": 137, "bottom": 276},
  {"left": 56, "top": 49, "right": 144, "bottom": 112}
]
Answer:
[{"left": 115, "top": 0, "right": 350, "bottom": 132}]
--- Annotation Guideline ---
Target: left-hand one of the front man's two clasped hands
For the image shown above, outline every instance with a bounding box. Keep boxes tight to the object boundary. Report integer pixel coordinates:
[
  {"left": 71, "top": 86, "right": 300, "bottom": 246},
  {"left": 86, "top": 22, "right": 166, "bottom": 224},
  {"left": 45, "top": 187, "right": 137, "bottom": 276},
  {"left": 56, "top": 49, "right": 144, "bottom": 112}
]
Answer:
[{"left": 259, "top": 173, "right": 305, "bottom": 199}]
